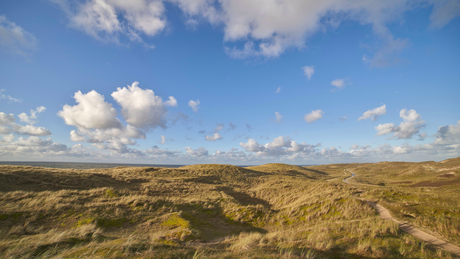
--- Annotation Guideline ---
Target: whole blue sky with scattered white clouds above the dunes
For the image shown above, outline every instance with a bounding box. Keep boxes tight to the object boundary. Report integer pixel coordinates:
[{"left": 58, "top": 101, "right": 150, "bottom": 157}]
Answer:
[{"left": 0, "top": 0, "right": 460, "bottom": 165}]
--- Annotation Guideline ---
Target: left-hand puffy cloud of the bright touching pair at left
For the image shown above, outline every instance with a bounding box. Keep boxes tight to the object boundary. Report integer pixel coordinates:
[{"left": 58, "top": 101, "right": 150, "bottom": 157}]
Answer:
[{"left": 58, "top": 90, "right": 122, "bottom": 129}]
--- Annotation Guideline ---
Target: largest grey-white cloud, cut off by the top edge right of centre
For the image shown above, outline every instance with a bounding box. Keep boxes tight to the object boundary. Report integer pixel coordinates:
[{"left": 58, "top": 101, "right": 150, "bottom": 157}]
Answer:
[{"left": 186, "top": 0, "right": 438, "bottom": 59}]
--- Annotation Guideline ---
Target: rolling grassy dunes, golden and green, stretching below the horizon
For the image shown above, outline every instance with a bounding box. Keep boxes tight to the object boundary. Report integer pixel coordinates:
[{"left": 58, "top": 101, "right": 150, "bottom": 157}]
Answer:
[{"left": 0, "top": 158, "right": 460, "bottom": 258}]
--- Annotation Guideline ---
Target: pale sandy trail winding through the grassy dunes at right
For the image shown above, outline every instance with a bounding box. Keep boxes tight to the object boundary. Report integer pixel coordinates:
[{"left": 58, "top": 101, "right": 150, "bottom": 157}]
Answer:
[{"left": 343, "top": 169, "right": 460, "bottom": 256}]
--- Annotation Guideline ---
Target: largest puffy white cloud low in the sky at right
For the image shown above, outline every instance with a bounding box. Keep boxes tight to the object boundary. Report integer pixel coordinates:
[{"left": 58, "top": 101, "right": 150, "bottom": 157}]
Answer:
[{"left": 375, "top": 109, "right": 425, "bottom": 139}]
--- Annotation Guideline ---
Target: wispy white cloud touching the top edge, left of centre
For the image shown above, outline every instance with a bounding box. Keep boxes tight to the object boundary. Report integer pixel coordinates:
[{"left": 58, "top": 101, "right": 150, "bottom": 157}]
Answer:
[{"left": 51, "top": 0, "right": 166, "bottom": 44}]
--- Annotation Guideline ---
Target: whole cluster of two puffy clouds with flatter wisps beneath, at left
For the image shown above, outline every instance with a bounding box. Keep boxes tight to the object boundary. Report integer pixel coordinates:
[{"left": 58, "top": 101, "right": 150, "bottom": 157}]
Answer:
[{"left": 58, "top": 82, "right": 180, "bottom": 152}]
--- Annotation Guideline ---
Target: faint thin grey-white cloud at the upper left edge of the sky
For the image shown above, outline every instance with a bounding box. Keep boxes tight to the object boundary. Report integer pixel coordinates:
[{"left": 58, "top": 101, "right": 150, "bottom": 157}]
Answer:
[{"left": 0, "top": 15, "right": 37, "bottom": 58}]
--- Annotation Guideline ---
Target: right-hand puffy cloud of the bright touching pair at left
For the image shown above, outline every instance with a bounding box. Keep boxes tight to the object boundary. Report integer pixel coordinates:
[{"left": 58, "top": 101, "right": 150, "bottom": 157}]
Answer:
[{"left": 112, "top": 82, "right": 177, "bottom": 130}]
